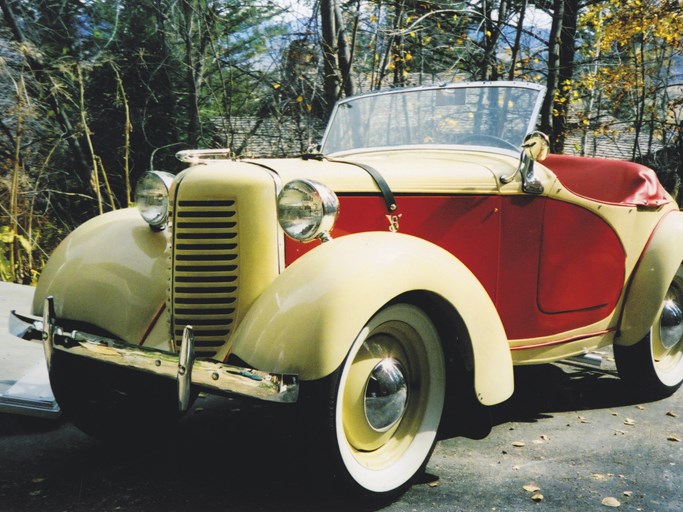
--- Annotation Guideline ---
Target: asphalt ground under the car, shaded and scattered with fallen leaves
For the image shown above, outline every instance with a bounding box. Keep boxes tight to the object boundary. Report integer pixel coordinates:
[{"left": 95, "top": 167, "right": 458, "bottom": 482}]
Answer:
[{"left": 0, "top": 287, "right": 683, "bottom": 512}]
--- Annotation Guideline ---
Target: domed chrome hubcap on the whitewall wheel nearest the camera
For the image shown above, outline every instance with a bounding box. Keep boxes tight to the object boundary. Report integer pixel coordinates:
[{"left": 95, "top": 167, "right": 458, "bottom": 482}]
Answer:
[{"left": 365, "top": 358, "right": 408, "bottom": 432}]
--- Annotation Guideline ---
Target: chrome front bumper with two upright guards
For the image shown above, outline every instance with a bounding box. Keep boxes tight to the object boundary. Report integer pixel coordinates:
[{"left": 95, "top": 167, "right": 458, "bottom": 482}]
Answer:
[{"left": 9, "top": 297, "right": 299, "bottom": 411}]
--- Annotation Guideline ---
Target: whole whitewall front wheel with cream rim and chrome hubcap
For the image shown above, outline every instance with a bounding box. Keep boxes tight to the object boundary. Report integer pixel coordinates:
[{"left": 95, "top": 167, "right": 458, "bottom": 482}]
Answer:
[{"left": 302, "top": 304, "right": 445, "bottom": 500}]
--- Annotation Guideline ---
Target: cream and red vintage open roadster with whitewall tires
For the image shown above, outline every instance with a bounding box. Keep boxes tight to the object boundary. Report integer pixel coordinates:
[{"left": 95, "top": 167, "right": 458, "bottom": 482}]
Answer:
[{"left": 6, "top": 82, "right": 683, "bottom": 498}]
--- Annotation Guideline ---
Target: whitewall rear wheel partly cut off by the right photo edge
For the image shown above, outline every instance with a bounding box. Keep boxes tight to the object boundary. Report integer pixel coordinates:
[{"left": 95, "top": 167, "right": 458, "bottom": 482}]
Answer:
[{"left": 614, "top": 265, "right": 683, "bottom": 398}]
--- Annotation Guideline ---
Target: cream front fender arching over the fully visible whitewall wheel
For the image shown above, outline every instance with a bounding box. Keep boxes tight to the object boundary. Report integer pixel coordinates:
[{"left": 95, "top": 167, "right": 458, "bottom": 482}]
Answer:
[{"left": 232, "top": 232, "right": 513, "bottom": 405}]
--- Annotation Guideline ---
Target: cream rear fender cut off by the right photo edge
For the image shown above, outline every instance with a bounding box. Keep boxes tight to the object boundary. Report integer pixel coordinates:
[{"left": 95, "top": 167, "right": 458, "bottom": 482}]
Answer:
[{"left": 615, "top": 211, "right": 683, "bottom": 346}]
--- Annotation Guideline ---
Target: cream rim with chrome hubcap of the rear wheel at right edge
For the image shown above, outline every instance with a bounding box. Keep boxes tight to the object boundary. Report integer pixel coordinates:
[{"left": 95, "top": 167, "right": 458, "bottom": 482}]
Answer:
[{"left": 652, "top": 272, "right": 683, "bottom": 374}]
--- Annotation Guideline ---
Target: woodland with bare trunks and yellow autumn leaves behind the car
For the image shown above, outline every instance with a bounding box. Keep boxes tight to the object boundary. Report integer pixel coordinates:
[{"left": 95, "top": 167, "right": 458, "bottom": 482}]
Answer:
[{"left": 0, "top": 0, "right": 683, "bottom": 283}]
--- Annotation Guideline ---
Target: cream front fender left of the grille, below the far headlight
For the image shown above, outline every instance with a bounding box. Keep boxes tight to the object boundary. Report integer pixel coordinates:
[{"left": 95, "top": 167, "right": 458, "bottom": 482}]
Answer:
[{"left": 33, "top": 208, "right": 168, "bottom": 343}]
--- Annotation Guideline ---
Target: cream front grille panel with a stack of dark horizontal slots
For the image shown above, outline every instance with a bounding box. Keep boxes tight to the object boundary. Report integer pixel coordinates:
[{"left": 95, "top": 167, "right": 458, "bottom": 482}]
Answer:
[{"left": 171, "top": 199, "right": 239, "bottom": 357}]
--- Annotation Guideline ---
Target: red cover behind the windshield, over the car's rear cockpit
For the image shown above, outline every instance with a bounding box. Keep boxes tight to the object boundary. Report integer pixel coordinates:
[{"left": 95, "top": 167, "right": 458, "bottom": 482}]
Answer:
[{"left": 543, "top": 155, "right": 670, "bottom": 207}]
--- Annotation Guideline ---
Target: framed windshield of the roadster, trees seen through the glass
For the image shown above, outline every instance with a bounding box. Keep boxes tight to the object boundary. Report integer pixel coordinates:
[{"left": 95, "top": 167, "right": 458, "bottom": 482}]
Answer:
[{"left": 322, "top": 82, "right": 545, "bottom": 154}]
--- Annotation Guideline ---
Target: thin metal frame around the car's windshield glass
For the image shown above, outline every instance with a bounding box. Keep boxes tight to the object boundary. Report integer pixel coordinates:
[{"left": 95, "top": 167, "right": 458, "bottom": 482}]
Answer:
[{"left": 320, "top": 81, "right": 546, "bottom": 156}]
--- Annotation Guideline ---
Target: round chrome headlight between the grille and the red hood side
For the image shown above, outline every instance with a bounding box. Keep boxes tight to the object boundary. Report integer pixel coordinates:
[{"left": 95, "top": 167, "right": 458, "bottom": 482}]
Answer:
[{"left": 277, "top": 180, "right": 339, "bottom": 242}]
